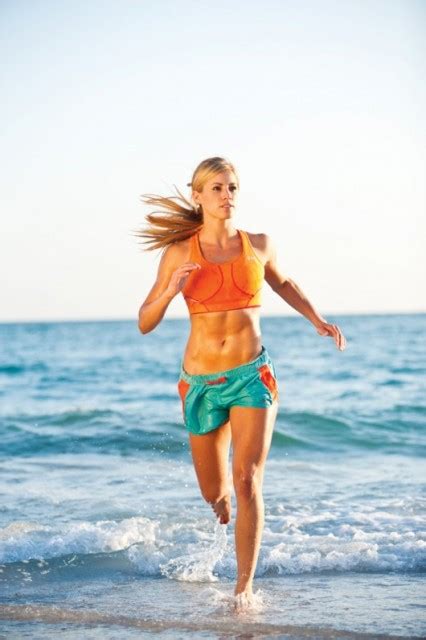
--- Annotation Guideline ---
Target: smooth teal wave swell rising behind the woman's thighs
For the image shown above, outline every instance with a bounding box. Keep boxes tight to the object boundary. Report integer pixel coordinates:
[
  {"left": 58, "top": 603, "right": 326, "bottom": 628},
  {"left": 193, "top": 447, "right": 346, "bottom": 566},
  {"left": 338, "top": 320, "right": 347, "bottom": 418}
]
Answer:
[{"left": 0, "top": 399, "right": 426, "bottom": 457}]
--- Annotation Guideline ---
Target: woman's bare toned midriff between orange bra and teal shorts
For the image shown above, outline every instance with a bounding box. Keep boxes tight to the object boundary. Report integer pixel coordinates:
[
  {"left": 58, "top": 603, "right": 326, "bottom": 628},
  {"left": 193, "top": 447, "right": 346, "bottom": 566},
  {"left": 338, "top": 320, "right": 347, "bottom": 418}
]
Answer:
[{"left": 183, "top": 307, "right": 262, "bottom": 375}]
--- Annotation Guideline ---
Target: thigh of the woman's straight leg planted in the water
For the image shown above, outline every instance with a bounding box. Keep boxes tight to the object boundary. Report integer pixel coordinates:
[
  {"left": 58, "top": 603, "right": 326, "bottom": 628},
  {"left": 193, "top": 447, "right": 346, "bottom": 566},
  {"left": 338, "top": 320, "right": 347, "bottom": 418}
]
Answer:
[{"left": 230, "top": 402, "right": 278, "bottom": 478}]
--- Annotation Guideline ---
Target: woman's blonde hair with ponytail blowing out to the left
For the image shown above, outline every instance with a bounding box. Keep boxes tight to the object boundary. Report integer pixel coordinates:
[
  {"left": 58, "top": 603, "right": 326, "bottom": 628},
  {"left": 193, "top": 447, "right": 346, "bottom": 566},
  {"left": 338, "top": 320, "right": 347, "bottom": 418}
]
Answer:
[{"left": 135, "top": 157, "right": 239, "bottom": 251}]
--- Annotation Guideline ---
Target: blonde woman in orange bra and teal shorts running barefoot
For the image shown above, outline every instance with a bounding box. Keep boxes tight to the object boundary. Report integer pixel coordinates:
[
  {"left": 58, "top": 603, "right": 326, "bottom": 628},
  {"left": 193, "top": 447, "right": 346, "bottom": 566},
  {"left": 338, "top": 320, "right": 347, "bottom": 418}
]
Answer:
[{"left": 138, "top": 157, "right": 346, "bottom": 601}]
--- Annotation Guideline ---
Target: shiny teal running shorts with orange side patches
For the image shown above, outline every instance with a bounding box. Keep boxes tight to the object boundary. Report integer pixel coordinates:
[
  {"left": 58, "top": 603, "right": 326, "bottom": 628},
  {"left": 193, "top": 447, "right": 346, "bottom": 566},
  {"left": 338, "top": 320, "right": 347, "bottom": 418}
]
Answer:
[{"left": 178, "top": 346, "right": 278, "bottom": 435}]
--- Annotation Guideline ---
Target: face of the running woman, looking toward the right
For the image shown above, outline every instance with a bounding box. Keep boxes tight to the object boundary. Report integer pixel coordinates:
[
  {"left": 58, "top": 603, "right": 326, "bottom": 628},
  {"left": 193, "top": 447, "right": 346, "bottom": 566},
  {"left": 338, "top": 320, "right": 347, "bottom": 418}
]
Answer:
[{"left": 192, "top": 171, "right": 238, "bottom": 220}]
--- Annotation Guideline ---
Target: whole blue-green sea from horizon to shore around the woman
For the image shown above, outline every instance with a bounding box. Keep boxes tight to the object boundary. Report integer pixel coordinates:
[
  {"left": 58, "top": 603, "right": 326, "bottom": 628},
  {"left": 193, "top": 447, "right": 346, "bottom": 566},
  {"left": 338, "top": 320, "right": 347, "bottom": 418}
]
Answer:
[{"left": 0, "top": 314, "right": 426, "bottom": 640}]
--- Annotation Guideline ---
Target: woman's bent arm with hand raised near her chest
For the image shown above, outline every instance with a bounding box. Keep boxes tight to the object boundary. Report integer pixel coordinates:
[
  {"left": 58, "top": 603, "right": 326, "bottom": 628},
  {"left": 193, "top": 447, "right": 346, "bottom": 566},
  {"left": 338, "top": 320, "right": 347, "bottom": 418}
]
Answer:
[{"left": 138, "top": 244, "right": 199, "bottom": 333}]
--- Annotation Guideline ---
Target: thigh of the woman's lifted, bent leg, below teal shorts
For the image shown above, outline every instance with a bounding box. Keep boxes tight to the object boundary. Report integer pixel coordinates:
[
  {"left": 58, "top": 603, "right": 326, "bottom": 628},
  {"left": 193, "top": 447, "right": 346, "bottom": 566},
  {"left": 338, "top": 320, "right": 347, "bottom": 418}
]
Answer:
[{"left": 189, "top": 420, "right": 231, "bottom": 501}]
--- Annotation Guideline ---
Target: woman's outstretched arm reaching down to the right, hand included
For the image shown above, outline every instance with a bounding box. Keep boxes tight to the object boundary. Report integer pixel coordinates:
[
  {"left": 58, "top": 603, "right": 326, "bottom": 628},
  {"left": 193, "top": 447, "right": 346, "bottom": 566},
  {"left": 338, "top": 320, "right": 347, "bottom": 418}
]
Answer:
[{"left": 265, "top": 236, "right": 346, "bottom": 351}]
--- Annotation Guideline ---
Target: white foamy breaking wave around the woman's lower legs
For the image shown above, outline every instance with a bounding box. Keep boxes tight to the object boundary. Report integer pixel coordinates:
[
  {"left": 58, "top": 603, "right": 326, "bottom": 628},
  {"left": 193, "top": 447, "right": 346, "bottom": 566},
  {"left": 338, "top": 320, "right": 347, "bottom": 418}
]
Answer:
[{"left": 0, "top": 511, "right": 426, "bottom": 581}]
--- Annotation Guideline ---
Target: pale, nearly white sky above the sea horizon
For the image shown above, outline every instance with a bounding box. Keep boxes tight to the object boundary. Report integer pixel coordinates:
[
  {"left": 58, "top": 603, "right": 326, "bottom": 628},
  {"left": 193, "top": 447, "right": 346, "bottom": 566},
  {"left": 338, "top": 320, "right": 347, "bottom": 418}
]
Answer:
[{"left": 0, "top": 0, "right": 426, "bottom": 322}]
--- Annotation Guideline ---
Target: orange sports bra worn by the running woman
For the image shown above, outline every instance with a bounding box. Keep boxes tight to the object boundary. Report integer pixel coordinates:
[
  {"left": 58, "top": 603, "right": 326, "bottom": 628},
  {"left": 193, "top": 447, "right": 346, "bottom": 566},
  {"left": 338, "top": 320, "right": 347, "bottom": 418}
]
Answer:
[{"left": 182, "top": 229, "right": 265, "bottom": 315}]
